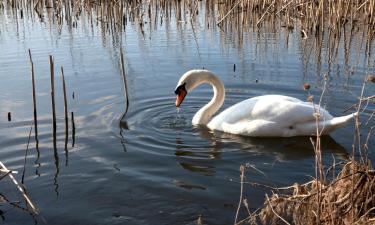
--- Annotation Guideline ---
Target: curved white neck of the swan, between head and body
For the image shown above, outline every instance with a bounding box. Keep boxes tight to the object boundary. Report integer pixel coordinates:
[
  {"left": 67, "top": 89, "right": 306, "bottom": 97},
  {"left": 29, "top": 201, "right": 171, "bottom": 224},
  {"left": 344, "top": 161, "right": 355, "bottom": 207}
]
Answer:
[{"left": 192, "top": 73, "right": 225, "bottom": 125}]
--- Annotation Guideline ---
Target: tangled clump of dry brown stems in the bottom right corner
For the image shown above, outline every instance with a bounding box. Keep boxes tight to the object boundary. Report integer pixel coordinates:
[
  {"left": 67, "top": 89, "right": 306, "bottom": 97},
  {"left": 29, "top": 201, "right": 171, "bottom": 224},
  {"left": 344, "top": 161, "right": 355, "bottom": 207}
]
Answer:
[{"left": 258, "top": 161, "right": 375, "bottom": 224}]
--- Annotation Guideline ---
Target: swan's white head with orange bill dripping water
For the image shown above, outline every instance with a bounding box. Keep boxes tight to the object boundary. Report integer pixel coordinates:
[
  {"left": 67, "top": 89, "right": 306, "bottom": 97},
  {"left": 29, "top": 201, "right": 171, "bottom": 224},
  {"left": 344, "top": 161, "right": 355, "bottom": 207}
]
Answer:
[{"left": 174, "top": 70, "right": 213, "bottom": 107}]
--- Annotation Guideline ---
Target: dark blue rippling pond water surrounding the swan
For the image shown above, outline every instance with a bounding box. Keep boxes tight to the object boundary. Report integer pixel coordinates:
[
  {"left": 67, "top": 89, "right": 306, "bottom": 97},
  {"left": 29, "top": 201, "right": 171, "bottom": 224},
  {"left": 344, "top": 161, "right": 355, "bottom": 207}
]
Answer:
[{"left": 0, "top": 3, "right": 375, "bottom": 224}]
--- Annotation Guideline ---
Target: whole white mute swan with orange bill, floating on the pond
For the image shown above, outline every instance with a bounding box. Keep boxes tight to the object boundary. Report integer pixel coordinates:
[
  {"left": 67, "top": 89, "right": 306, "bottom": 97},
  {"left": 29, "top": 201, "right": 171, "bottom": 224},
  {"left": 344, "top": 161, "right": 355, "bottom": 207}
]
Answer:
[{"left": 175, "top": 70, "right": 355, "bottom": 137}]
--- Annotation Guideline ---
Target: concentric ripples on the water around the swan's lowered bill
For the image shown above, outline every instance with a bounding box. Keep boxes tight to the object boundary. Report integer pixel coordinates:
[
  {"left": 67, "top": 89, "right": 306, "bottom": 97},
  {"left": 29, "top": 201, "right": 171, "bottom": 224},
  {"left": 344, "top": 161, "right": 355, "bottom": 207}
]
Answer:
[{"left": 124, "top": 93, "right": 229, "bottom": 159}]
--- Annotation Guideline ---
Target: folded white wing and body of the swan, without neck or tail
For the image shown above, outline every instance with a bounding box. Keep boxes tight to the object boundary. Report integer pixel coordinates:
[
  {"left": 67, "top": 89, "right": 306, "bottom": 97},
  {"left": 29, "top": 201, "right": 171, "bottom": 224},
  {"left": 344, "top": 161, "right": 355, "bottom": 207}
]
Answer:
[{"left": 208, "top": 95, "right": 332, "bottom": 133}]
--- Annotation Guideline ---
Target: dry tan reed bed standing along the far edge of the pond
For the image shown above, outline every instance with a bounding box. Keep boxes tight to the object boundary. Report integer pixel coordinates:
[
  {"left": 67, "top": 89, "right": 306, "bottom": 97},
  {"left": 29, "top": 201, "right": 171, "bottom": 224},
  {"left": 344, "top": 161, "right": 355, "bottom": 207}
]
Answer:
[{"left": 0, "top": 0, "right": 375, "bottom": 37}]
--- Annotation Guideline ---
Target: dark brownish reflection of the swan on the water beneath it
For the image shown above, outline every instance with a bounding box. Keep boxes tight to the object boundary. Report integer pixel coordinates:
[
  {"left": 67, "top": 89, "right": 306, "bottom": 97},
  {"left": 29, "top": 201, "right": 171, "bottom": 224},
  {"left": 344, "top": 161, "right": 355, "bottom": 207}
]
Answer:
[{"left": 175, "top": 126, "right": 348, "bottom": 175}]
